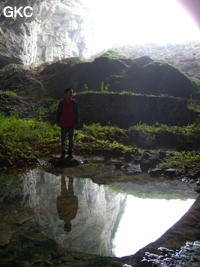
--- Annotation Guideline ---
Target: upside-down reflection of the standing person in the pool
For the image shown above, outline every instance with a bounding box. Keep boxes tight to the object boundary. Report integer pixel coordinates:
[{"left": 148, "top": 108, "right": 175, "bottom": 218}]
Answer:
[{"left": 57, "top": 174, "right": 78, "bottom": 232}]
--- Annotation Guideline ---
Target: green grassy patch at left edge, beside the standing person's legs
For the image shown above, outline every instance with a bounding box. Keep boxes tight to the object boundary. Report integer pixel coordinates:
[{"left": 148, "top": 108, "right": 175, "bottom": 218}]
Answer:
[{"left": 0, "top": 114, "right": 59, "bottom": 159}]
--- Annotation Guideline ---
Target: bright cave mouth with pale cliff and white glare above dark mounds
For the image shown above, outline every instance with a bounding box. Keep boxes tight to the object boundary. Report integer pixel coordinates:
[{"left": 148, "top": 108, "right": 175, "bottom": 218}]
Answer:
[{"left": 0, "top": 0, "right": 200, "bottom": 66}]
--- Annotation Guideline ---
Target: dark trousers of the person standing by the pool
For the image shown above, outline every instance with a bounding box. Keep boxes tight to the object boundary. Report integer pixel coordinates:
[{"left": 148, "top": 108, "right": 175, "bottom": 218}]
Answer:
[{"left": 61, "top": 126, "right": 74, "bottom": 154}]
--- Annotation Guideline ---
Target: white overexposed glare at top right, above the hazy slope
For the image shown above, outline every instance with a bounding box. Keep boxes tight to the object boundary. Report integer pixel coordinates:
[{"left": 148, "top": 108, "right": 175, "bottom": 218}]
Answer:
[{"left": 87, "top": 0, "right": 200, "bottom": 50}]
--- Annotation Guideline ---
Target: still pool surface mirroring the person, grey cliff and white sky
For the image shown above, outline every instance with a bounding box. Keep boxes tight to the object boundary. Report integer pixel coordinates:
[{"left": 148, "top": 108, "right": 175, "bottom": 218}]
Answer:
[{"left": 23, "top": 169, "right": 196, "bottom": 257}]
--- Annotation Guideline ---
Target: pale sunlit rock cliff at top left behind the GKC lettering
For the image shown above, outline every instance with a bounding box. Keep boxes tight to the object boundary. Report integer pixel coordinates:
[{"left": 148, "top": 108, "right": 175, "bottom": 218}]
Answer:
[{"left": 0, "top": 0, "right": 89, "bottom": 67}]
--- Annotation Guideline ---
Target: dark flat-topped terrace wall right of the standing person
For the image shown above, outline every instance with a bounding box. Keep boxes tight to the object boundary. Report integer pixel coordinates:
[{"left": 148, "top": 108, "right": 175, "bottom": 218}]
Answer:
[{"left": 76, "top": 93, "right": 198, "bottom": 128}]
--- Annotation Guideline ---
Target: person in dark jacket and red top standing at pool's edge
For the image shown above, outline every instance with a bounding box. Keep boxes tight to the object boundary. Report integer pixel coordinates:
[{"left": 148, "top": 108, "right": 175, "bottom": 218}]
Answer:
[{"left": 56, "top": 88, "right": 79, "bottom": 159}]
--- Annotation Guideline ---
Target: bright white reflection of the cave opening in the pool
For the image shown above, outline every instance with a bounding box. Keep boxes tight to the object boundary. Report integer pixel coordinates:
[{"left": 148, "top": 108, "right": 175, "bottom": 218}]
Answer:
[{"left": 113, "top": 195, "right": 194, "bottom": 257}]
